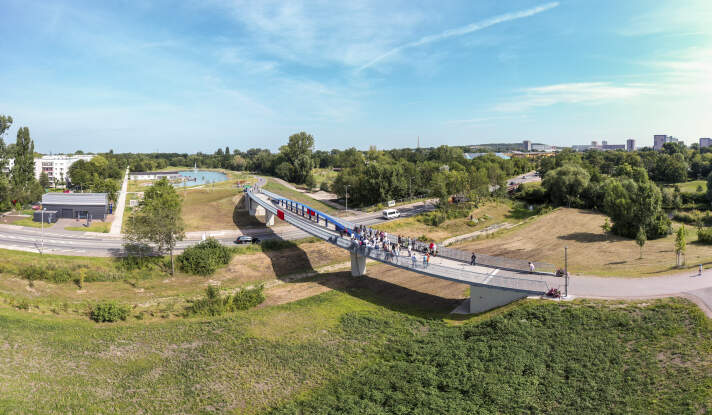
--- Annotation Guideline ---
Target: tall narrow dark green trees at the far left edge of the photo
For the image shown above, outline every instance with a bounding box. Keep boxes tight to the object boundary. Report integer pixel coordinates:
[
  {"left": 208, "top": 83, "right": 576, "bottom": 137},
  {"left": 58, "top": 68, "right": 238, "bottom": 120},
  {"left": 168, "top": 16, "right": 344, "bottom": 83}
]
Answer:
[{"left": 0, "top": 115, "right": 44, "bottom": 211}]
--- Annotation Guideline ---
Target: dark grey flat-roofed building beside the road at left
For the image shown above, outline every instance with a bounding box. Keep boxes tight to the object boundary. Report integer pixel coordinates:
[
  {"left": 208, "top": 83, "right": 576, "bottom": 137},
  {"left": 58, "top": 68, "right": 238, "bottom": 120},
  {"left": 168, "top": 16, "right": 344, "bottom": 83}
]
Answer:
[{"left": 42, "top": 192, "right": 109, "bottom": 220}]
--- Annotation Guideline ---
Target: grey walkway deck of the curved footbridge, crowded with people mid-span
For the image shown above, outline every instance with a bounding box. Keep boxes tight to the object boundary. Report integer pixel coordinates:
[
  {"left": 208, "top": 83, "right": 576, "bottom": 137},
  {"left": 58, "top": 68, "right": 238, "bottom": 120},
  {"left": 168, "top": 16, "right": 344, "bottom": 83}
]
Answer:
[{"left": 247, "top": 189, "right": 549, "bottom": 295}]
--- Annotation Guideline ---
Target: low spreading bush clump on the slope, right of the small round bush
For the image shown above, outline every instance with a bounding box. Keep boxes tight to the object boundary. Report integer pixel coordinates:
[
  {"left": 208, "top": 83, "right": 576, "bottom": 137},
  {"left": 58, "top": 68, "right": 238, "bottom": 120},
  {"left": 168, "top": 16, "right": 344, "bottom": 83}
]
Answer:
[{"left": 186, "top": 285, "right": 265, "bottom": 316}]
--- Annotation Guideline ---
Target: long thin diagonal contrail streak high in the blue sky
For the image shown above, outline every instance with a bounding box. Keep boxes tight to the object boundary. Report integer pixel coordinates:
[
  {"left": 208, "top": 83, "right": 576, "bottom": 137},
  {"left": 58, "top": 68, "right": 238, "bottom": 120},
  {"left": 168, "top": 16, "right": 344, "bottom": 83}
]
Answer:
[{"left": 358, "top": 2, "right": 559, "bottom": 71}]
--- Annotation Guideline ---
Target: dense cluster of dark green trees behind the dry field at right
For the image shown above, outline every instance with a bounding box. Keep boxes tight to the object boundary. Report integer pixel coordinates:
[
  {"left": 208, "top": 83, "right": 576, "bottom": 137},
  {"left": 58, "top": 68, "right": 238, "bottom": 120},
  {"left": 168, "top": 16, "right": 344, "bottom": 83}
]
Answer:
[{"left": 519, "top": 148, "right": 712, "bottom": 239}]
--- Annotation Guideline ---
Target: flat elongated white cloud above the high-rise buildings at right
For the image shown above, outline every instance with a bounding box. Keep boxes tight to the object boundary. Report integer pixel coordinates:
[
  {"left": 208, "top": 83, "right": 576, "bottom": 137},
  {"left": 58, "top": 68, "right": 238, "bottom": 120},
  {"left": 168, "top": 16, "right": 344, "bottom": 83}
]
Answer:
[{"left": 495, "top": 82, "right": 655, "bottom": 112}]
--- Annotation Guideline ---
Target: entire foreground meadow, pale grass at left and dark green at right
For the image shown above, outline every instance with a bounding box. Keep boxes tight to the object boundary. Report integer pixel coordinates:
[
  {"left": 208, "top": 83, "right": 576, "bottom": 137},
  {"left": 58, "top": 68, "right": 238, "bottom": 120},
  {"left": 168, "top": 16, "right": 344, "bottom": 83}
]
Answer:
[{"left": 0, "top": 298, "right": 712, "bottom": 414}]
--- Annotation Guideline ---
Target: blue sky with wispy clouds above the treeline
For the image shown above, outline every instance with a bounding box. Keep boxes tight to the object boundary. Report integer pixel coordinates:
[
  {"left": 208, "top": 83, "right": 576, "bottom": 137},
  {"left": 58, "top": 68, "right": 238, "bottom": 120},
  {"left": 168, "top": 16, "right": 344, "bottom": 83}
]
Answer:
[{"left": 0, "top": 0, "right": 712, "bottom": 153}]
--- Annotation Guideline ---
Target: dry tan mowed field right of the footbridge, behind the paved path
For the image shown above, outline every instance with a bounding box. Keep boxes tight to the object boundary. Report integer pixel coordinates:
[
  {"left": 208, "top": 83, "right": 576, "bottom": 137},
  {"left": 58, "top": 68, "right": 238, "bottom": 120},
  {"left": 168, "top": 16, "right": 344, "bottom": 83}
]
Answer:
[{"left": 454, "top": 208, "right": 712, "bottom": 277}]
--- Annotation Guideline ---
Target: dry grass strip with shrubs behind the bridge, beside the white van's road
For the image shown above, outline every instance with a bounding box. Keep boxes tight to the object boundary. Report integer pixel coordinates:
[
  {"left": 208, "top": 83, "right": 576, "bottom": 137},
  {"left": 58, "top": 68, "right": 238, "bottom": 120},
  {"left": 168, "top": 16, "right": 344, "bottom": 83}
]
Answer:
[{"left": 374, "top": 200, "right": 534, "bottom": 242}]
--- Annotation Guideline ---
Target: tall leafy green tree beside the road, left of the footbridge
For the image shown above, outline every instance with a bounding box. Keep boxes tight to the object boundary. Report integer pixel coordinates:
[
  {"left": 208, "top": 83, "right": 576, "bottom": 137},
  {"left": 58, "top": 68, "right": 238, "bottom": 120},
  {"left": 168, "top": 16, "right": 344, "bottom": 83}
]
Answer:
[{"left": 125, "top": 179, "right": 185, "bottom": 275}]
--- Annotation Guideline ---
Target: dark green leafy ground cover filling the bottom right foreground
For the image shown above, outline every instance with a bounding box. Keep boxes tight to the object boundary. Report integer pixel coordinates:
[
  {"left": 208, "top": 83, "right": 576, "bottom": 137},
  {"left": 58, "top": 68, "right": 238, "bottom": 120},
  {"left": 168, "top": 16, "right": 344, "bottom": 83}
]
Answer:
[{"left": 273, "top": 300, "right": 712, "bottom": 414}]
